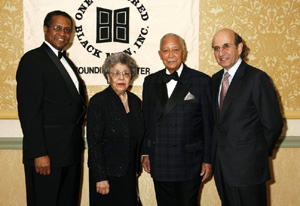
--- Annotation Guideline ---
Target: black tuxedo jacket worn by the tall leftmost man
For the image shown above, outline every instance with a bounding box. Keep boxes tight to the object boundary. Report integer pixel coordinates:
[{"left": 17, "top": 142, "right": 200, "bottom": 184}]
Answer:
[{"left": 16, "top": 43, "right": 86, "bottom": 167}]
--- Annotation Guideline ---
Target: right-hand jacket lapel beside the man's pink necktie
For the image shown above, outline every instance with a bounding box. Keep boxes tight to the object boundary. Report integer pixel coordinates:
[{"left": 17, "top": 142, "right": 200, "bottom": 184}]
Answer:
[{"left": 220, "top": 61, "right": 246, "bottom": 116}]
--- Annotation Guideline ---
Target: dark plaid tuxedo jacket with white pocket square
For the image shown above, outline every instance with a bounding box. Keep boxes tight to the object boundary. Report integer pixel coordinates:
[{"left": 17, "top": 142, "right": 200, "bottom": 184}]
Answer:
[{"left": 143, "top": 65, "right": 213, "bottom": 182}]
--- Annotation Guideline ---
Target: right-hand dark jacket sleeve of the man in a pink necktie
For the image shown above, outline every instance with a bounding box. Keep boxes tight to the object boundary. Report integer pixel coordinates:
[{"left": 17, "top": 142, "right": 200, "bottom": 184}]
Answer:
[{"left": 253, "top": 72, "right": 283, "bottom": 156}]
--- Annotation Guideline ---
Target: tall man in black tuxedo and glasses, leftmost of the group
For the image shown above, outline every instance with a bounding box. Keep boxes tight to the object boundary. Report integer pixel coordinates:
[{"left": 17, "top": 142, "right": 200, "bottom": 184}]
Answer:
[{"left": 16, "top": 11, "right": 86, "bottom": 206}]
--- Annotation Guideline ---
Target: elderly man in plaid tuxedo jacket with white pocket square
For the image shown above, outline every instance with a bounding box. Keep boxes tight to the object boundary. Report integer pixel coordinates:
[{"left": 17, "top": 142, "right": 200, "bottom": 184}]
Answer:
[{"left": 143, "top": 34, "right": 213, "bottom": 206}]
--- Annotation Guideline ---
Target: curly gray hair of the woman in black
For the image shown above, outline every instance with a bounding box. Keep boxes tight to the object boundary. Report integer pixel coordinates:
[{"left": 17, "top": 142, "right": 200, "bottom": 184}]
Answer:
[{"left": 102, "top": 52, "right": 138, "bottom": 80}]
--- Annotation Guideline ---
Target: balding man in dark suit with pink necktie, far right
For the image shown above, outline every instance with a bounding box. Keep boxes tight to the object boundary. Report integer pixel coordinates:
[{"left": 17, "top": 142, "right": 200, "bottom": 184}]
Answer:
[{"left": 212, "top": 29, "right": 283, "bottom": 206}]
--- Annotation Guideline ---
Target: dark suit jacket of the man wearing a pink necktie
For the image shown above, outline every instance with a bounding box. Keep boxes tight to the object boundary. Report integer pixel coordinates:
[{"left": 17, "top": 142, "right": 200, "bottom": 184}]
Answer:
[{"left": 212, "top": 61, "right": 283, "bottom": 186}]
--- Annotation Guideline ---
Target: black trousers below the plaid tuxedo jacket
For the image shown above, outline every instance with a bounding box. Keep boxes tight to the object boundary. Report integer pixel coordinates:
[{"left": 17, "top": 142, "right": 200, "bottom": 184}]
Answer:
[{"left": 153, "top": 174, "right": 202, "bottom": 206}]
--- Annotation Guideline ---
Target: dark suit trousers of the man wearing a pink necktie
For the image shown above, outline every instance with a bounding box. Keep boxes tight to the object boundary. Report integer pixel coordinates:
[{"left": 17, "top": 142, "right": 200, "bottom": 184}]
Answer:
[{"left": 214, "top": 152, "right": 267, "bottom": 206}]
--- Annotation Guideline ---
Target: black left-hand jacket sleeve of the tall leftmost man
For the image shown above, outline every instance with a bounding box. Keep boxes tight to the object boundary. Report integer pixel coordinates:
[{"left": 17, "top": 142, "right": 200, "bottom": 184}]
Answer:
[{"left": 16, "top": 55, "right": 47, "bottom": 159}]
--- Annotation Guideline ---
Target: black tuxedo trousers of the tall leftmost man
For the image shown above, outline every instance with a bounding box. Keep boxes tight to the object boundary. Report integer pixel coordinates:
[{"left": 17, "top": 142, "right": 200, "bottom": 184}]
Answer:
[{"left": 25, "top": 161, "right": 82, "bottom": 206}]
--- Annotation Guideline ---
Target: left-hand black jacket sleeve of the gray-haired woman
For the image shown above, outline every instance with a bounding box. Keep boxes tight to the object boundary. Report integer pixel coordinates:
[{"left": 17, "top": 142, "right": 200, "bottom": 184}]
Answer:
[{"left": 87, "top": 96, "right": 107, "bottom": 182}]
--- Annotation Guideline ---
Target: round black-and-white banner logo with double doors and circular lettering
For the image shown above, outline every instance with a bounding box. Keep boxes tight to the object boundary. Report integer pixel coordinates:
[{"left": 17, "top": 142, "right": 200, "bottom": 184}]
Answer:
[{"left": 75, "top": 0, "right": 149, "bottom": 59}]
